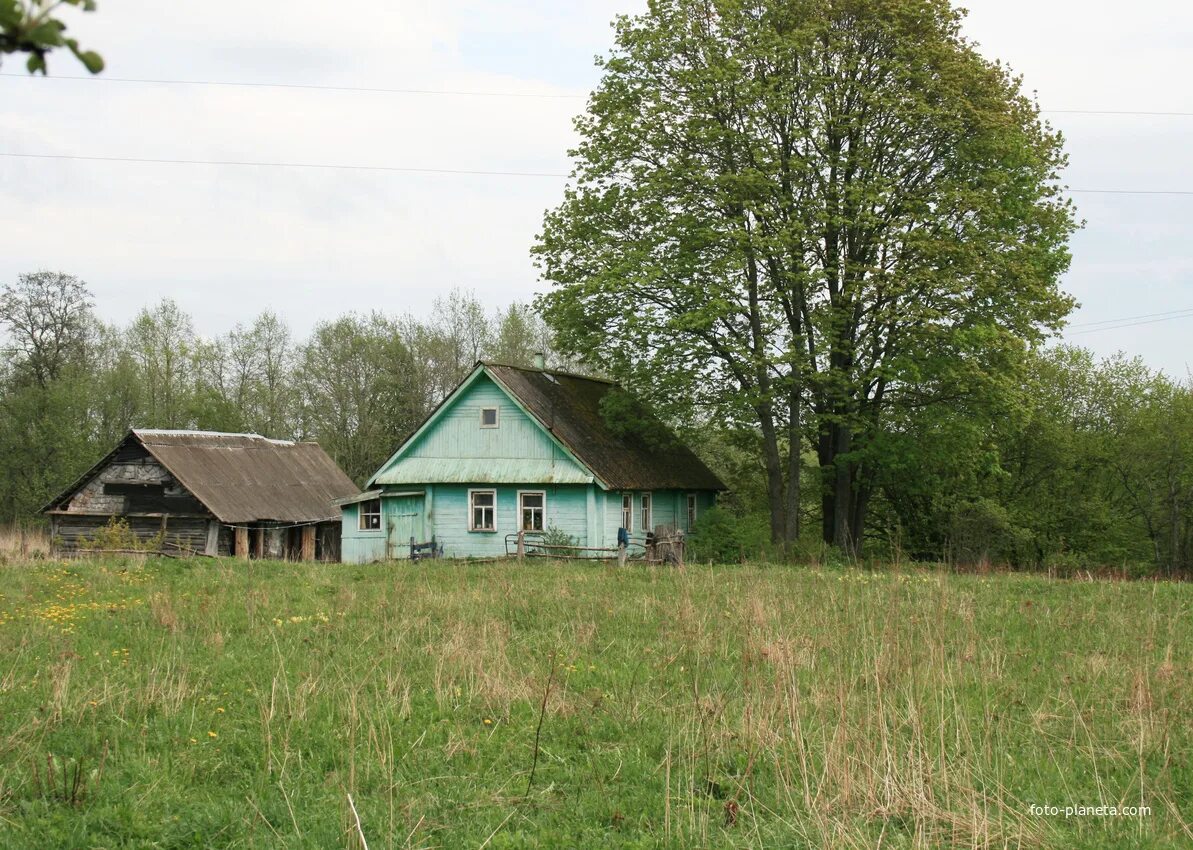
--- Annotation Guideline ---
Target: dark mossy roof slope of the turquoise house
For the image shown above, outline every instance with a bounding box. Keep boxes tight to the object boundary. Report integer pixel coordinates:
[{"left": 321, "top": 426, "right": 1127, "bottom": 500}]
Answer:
[{"left": 483, "top": 363, "right": 725, "bottom": 489}]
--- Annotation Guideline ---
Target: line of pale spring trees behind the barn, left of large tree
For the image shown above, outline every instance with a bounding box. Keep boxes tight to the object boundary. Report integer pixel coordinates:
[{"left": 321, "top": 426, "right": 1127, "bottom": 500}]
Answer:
[{"left": 0, "top": 271, "right": 560, "bottom": 523}]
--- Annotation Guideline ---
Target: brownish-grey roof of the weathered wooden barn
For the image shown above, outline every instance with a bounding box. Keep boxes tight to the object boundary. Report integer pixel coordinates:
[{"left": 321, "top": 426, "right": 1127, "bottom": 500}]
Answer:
[{"left": 50, "top": 430, "right": 360, "bottom": 523}]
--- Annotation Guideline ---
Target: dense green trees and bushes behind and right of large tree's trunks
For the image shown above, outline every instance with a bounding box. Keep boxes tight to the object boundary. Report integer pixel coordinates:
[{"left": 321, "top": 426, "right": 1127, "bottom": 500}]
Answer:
[{"left": 698, "top": 345, "right": 1193, "bottom": 575}]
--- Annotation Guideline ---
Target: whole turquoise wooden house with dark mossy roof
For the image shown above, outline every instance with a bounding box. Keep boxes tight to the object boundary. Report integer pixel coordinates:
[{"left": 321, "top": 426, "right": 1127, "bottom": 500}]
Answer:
[{"left": 340, "top": 363, "right": 724, "bottom": 563}]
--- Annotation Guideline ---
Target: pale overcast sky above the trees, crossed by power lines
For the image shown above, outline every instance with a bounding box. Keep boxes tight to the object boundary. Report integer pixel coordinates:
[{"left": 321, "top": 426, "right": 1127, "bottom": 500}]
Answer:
[{"left": 0, "top": 0, "right": 1193, "bottom": 376}]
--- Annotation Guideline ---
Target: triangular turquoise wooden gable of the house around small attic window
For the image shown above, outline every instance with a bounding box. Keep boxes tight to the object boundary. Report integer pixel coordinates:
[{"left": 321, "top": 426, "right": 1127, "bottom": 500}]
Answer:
[{"left": 371, "top": 374, "right": 592, "bottom": 485}]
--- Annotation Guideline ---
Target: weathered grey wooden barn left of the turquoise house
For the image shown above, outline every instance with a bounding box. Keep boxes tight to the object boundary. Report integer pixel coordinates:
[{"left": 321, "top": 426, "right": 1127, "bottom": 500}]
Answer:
[{"left": 43, "top": 429, "right": 359, "bottom": 561}]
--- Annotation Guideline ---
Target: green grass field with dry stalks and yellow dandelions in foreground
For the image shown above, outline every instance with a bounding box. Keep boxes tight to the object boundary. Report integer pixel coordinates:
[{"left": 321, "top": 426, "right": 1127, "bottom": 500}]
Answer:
[{"left": 0, "top": 559, "right": 1193, "bottom": 850}]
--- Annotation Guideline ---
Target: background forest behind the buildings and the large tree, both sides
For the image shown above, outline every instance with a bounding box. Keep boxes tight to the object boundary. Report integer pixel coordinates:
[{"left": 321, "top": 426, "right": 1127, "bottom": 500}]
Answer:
[{"left": 0, "top": 272, "right": 1193, "bottom": 574}]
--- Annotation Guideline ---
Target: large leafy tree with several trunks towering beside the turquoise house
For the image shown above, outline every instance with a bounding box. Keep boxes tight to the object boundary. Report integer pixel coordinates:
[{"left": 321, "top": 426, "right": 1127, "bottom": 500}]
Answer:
[{"left": 536, "top": 0, "right": 1074, "bottom": 549}]
